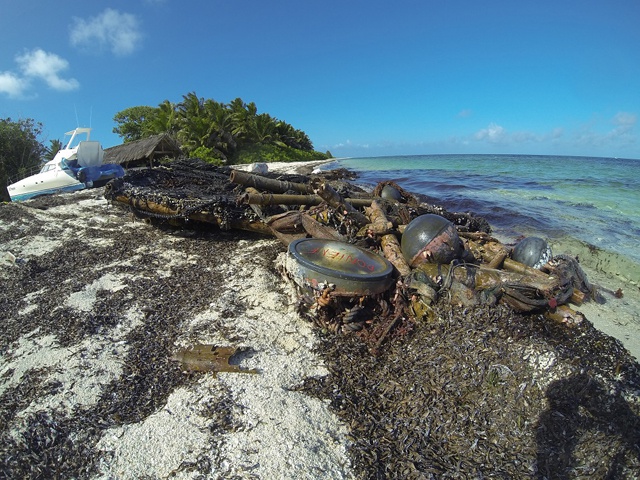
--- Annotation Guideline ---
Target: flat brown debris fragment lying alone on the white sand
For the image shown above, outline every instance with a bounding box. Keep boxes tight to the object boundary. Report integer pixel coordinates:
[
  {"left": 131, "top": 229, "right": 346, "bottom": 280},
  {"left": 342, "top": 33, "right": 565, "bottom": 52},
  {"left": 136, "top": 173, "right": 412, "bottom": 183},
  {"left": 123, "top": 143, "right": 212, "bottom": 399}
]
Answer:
[{"left": 171, "top": 344, "right": 258, "bottom": 374}]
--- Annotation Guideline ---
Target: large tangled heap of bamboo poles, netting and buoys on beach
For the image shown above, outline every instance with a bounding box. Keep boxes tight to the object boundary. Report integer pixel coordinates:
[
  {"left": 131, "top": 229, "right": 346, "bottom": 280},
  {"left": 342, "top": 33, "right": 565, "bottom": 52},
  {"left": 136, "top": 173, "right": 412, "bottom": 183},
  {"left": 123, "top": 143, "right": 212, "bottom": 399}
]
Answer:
[{"left": 105, "top": 159, "right": 601, "bottom": 352}]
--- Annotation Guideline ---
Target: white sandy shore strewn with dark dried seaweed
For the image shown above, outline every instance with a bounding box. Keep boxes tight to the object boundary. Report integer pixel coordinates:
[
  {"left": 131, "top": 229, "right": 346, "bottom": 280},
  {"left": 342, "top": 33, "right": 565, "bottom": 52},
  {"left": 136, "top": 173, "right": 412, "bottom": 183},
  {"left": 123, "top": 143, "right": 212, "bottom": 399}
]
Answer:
[{"left": 0, "top": 164, "right": 640, "bottom": 479}]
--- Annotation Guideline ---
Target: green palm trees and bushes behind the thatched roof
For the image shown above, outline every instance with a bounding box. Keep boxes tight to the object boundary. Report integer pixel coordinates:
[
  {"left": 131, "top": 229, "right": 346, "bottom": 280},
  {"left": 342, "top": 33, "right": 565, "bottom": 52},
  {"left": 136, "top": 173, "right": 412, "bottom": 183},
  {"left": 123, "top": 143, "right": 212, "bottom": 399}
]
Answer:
[{"left": 113, "top": 92, "right": 329, "bottom": 164}]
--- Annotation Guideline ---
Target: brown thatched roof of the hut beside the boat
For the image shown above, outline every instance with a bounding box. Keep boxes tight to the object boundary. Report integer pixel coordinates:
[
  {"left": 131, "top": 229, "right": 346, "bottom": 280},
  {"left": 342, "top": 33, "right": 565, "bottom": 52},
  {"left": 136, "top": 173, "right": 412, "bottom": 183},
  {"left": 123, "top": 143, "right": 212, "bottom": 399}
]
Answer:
[{"left": 104, "top": 133, "right": 182, "bottom": 168}]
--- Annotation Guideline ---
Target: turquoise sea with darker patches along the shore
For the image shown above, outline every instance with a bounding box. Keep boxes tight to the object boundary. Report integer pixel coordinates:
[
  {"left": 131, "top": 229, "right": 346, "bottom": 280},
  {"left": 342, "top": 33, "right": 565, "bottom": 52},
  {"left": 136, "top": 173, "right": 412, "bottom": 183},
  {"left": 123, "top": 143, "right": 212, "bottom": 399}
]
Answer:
[{"left": 324, "top": 155, "right": 640, "bottom": 282}]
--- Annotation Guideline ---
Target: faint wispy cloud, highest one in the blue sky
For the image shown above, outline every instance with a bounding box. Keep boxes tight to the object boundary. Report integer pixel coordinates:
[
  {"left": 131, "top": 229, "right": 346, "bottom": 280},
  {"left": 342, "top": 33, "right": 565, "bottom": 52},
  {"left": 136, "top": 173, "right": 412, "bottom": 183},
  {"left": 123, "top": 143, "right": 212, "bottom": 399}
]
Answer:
[{"left": 70, "top": 8, "right": 142, "bottom": 56}]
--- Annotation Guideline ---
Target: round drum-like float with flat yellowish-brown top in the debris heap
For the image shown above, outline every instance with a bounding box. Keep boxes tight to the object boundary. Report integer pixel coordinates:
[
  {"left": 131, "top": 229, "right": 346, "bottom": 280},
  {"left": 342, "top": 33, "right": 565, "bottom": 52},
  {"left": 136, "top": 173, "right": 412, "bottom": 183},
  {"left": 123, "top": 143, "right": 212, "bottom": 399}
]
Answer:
[{"left": 289, "top": 238, "right": 393, "bottom": 295}]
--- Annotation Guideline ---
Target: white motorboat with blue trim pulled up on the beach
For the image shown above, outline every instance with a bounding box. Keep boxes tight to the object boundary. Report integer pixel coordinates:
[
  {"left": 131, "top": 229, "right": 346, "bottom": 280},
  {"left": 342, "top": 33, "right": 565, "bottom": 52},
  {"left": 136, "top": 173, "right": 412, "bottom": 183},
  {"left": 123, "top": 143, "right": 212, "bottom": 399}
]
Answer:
[{"left": 7, "top": 128, "right": 124, "bottom": 202}]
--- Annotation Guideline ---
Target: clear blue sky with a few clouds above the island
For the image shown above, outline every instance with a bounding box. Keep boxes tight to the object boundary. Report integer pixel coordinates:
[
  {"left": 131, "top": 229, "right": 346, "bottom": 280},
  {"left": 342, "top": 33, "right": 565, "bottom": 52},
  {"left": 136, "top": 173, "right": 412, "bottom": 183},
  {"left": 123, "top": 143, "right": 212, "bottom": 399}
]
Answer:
[{"left": 0, "top": 0, "right": 640, "bottom": 158}]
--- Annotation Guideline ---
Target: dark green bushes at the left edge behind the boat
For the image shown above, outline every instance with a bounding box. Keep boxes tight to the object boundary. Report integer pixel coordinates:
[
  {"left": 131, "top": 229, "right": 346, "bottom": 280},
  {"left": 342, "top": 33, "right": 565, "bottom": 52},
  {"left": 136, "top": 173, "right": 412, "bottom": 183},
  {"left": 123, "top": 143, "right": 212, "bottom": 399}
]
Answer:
[{"left": 0, "top": 118, "right": 45, "bottom": 201}]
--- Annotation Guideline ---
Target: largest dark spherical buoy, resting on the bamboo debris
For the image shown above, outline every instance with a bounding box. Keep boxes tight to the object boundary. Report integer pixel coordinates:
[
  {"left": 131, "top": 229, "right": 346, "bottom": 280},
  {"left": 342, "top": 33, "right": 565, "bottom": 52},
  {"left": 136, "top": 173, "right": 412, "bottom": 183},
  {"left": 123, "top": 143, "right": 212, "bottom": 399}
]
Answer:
[{"left": 400, "top": 214, "right": 464, "bottom": 267}]
